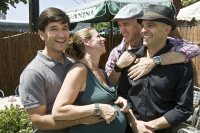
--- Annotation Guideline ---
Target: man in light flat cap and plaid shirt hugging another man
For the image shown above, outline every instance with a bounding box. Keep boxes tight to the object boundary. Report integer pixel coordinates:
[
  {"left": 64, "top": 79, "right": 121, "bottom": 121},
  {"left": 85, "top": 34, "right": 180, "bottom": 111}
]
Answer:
[{"left": 105, "top": 4, "right": 200, "bottom": 85}]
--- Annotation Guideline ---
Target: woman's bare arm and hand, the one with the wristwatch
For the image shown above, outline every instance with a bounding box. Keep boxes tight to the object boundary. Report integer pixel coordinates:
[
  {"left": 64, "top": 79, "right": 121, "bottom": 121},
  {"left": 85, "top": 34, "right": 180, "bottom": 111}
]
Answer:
[{"left": 52, "top": 64, "right": 117, "bottom": 123}]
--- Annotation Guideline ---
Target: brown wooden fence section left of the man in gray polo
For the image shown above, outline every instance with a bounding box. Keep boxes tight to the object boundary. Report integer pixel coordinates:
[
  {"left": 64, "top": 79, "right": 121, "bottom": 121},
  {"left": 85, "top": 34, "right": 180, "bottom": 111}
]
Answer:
[{"left": 0, "top": 32, "right": 44, "bottom": 95}]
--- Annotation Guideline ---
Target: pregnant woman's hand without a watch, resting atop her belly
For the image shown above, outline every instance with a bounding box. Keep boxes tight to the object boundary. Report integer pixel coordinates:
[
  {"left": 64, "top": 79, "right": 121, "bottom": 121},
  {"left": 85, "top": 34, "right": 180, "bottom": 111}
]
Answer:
[{"left": 115, "top": 97, "right": 130, "bottom": 112}]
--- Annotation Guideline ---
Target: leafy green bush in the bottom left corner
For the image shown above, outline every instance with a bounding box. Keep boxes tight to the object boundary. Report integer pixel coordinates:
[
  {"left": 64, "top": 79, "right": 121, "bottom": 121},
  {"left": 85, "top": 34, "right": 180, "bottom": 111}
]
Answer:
[{"left": 0, "top": 105, "right": 33, "bottom": 133}]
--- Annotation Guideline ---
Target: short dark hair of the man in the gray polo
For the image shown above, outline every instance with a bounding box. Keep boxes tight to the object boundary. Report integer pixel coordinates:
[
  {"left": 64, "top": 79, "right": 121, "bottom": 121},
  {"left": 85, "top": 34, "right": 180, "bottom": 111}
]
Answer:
[{"left": 38, "top": 7, "right": 70, "bottom": 31}]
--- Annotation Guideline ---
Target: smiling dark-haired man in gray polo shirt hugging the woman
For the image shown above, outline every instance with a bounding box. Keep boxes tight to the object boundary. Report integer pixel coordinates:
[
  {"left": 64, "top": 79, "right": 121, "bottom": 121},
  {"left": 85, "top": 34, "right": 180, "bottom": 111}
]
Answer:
[{"left": 19, "top": 7, "right": 102, "bottom": 133}]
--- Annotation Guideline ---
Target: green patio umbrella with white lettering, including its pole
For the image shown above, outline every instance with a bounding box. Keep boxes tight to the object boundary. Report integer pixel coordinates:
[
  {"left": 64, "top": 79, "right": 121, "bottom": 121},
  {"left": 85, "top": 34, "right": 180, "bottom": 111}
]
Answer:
[{"left": 65, "top": 0, "right": 175, "bottom": 48}]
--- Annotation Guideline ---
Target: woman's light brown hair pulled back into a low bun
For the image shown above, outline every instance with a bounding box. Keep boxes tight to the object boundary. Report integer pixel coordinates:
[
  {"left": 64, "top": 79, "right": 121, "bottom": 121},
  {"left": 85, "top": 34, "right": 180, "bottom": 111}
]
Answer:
[{"left": 65, "top": 27, "right": 94, "bottom": 60}]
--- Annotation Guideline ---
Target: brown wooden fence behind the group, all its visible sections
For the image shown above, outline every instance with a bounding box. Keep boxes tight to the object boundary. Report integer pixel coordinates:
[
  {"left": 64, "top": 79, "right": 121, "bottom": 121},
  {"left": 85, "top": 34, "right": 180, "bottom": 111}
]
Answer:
[{"left": 0, "top": 26, "right": 200, "bottom": 96}]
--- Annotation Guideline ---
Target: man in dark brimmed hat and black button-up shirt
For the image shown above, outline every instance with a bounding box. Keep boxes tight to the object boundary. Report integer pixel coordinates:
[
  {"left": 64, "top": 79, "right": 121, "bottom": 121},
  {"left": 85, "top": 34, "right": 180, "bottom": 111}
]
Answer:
[{"left": 128, "top": 4, "right": 193, "bottom": 133}]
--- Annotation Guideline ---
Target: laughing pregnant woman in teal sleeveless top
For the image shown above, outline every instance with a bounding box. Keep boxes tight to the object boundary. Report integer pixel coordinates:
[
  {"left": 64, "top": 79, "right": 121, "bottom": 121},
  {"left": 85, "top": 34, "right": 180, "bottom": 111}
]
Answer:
[{"left": 52, "top": 28, "right": 128, "bottom": 133}]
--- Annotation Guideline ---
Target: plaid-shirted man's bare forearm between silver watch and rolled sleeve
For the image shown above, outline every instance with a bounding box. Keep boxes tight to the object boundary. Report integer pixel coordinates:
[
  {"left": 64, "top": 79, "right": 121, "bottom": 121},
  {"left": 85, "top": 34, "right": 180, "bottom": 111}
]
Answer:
[{"left": 160, "top": 51, "right": 186, "bottom": 65}]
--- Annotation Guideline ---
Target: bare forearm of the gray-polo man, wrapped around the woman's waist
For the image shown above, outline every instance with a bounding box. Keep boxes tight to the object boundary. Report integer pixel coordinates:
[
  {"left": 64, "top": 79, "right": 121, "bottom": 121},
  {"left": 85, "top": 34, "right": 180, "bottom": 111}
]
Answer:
[{"left": 27, "top": 105, "right": 103, "bottom": 130}]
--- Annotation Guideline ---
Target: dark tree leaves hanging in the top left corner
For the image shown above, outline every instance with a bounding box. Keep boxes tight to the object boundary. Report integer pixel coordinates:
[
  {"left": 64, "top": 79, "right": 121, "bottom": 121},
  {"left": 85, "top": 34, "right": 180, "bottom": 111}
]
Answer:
[{"left": 0, "top": 0, "right": 28, "bottom": 14}]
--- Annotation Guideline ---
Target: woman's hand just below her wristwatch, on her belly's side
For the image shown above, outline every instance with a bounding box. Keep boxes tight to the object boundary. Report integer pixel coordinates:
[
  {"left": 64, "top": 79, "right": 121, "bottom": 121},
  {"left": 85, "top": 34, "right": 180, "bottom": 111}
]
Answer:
[{"left": 99, "top": 104, "right": 117, "bottom": 124}]
